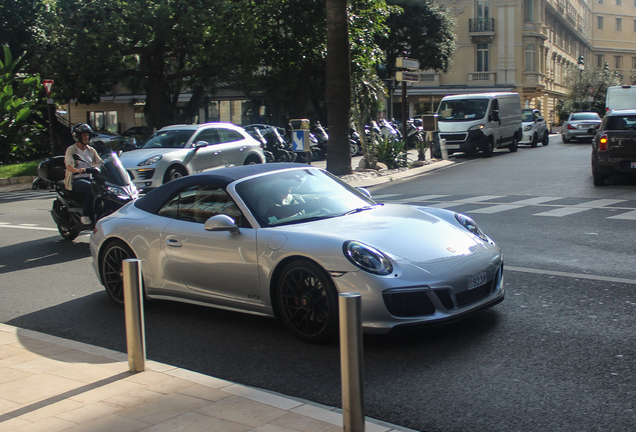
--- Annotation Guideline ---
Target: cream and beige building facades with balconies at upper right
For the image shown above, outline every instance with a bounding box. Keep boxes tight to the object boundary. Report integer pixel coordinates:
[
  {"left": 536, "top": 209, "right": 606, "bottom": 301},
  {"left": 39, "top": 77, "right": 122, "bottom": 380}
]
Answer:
[{"left": 389, "top": 0, "right": 636, "bottom": 124}]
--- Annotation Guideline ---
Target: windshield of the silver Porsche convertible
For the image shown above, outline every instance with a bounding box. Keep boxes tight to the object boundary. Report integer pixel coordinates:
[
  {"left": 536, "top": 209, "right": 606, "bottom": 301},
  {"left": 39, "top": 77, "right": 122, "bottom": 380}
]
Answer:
[{"left": 236, "top": 169, "right": 380, "bottom": 227}]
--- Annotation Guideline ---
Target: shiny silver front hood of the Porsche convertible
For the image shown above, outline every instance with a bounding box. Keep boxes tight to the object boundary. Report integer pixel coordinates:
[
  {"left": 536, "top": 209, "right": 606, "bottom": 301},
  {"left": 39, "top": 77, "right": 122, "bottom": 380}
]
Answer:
[{"left": 281, "top": 204, "right": 483, "bottom": 263}]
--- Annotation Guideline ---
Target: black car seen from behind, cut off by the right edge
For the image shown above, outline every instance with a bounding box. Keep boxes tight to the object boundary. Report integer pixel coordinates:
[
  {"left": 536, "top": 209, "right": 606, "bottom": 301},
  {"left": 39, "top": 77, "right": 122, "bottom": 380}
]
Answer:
[{"left": 590, "top": 109, "right": 636, "bottom": 186}]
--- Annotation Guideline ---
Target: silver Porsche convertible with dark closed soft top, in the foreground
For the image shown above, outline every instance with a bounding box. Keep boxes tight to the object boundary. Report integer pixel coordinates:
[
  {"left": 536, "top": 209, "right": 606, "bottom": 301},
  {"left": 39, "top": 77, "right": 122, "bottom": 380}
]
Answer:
[{"left": 90, "top": 163, "right": 505, "bottom": 342}]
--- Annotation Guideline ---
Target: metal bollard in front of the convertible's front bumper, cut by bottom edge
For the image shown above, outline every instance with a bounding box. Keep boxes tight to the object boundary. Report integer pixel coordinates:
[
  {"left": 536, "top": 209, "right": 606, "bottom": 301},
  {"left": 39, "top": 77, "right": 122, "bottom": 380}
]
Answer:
[{"left": 338, "top": 293, "right": 364, "bottom": 432}]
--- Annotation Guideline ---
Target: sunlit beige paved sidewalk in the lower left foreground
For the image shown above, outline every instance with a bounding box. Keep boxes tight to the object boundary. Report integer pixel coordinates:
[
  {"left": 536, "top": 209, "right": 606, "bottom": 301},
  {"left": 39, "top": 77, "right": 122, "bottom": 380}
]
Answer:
[{"left": 0, "top": 324, "right": 418, "bottom": 432}]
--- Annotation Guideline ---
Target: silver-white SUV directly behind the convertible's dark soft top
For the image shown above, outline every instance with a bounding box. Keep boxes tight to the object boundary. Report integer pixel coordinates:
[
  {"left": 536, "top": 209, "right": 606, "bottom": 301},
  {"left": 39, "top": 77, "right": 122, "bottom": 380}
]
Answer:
[{"left": 120, "top": 123, "right": 265, "bottom": 190}]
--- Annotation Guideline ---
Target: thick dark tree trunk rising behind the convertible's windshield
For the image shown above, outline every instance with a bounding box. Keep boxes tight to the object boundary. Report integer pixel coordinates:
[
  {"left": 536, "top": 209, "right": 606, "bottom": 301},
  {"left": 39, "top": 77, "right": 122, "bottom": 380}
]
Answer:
[{"left": 325, "top": 0, "right": 351, "bottom": 175}]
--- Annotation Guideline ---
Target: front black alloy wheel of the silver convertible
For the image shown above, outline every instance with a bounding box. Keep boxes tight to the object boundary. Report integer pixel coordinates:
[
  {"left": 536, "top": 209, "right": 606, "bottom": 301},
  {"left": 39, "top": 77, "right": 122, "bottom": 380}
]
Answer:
[{"left": 276, "top": 260, "right": 338, "bottom": 343}]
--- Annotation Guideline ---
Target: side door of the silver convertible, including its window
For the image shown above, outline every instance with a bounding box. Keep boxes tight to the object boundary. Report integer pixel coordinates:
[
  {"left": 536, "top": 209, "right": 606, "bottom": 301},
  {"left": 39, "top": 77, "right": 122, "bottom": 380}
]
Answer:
[{"left": 160, "top": 185, "right": 262, "bottom": 303}]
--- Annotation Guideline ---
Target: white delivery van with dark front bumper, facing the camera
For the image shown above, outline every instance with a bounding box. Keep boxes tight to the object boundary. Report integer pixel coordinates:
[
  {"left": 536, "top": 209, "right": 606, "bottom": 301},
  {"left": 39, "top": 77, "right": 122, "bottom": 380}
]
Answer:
[{"left": 433, "top": 93, "right": 523, "bottom": 157}]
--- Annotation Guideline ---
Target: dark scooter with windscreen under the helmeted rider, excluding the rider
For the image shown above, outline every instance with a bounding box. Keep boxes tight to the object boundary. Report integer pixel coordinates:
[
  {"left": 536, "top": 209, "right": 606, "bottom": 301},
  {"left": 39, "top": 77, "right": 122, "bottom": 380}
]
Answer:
[{"left": 38, "top": 153, "right": 139, "bottom": 240}]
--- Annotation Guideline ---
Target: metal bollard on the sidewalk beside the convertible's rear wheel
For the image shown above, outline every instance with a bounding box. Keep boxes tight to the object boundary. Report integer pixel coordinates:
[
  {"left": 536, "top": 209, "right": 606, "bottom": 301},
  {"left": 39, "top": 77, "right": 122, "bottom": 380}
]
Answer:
[{"left": 122, "top": 259, "right": 146, "bottom": 373}]
